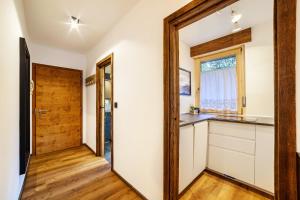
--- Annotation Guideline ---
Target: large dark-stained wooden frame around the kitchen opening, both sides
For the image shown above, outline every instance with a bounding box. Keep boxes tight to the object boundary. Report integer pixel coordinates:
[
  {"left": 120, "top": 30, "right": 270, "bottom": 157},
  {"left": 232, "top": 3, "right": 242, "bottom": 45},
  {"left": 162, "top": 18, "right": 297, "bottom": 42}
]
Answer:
[{"left": 164, "top": 0, "right": 297, "bottom": 200}]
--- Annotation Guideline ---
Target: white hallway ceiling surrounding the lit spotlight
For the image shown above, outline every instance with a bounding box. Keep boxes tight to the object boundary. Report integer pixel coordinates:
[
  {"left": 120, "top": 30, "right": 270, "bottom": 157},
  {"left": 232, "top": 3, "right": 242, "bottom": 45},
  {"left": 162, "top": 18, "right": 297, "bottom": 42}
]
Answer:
[{"left": 23, "top": 0, "right": 139, "bottom": 53}]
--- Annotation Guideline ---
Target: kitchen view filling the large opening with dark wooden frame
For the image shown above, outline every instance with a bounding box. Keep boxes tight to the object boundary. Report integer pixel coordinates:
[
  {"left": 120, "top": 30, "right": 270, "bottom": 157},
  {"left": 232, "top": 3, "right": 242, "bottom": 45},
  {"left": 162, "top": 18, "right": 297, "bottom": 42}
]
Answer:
[{"left": 178, "top": 0, "right": 274, "bottom": 199}]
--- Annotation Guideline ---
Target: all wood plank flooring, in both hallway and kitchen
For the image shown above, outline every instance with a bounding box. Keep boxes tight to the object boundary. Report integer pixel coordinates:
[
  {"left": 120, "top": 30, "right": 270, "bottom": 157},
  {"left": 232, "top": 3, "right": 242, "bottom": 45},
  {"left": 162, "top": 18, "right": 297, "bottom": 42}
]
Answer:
[{"left": 22, "top": 146, "right": 266, "bottom": 200}]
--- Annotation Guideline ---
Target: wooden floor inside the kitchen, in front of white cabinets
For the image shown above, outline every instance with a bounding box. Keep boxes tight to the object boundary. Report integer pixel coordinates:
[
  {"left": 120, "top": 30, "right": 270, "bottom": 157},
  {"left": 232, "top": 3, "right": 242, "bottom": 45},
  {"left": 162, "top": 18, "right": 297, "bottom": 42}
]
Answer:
[{"left": 180, "top": 172, "right": 267, "bottom": 200}]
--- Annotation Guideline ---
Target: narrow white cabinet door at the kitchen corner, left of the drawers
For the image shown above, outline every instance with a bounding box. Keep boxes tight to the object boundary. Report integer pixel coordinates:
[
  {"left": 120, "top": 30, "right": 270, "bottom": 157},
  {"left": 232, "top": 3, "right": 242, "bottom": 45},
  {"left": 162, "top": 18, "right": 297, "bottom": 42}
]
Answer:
[{"left": 193, "top": 121, "right": 208, "bottom": 179}]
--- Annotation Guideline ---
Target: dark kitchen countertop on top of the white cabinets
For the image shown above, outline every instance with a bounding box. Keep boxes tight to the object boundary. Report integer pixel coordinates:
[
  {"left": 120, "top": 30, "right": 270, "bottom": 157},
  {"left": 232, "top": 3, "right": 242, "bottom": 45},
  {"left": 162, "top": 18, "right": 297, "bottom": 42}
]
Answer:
[{"left": 179, "top": 113, "right": 274, "bottom": 127}]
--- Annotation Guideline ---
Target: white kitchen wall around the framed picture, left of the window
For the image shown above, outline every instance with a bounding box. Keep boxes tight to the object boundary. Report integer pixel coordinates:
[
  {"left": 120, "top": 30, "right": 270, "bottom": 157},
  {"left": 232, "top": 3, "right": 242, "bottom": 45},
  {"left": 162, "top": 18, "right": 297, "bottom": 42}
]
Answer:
[{"left": 179, "top": 41, "right": 195, "bottom": 113}]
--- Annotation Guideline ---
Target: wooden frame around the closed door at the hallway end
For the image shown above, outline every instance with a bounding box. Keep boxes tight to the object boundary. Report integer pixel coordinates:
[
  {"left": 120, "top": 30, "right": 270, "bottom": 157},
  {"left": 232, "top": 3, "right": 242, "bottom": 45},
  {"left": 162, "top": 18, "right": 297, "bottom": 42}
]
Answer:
[{"left": 31, "top": 63, "right": 83, "bottom": 156}]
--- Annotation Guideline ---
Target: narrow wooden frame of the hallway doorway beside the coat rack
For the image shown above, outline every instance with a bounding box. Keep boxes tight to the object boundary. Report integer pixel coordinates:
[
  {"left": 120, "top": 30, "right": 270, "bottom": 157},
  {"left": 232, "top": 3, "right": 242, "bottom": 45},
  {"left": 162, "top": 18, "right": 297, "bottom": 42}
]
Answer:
[{"left": 96, "top": 53, "right": 114, "bottom": 169}]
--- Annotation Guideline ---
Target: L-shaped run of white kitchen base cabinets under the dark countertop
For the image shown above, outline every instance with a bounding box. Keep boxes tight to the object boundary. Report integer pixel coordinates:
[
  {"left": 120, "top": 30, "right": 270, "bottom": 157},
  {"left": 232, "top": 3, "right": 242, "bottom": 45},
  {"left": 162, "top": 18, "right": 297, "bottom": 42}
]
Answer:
[{"left": 179, "top": 121, "right": 274, "bottom": 193}]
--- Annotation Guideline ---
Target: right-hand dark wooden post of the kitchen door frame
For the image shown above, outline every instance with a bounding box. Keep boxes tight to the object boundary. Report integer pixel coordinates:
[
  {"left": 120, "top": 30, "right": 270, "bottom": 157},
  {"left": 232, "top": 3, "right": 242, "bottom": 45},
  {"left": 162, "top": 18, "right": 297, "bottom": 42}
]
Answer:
[{"left": 274, "top": 0, "right": 297, "bottom": 200}]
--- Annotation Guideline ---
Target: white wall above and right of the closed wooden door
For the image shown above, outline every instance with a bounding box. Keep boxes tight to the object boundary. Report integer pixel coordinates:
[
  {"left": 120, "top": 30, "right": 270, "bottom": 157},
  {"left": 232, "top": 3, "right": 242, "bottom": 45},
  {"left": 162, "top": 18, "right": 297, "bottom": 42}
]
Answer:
[{"left": 30, "top": 43, "right": 87, "bottom": 143}]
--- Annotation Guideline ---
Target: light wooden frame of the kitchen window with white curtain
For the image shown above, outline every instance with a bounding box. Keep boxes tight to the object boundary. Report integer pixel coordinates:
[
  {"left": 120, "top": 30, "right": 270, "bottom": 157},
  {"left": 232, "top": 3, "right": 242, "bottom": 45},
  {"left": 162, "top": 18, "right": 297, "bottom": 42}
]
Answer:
[{"left": 194, "top": 45, "right": 246, "bottom": 115}]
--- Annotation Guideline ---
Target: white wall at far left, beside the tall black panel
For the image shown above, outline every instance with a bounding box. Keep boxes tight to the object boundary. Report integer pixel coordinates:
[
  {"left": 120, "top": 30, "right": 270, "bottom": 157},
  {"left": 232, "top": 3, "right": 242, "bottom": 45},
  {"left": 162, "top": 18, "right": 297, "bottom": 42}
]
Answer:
[{"left": 0, "top": 0, "right": 30, "bottom": 200}]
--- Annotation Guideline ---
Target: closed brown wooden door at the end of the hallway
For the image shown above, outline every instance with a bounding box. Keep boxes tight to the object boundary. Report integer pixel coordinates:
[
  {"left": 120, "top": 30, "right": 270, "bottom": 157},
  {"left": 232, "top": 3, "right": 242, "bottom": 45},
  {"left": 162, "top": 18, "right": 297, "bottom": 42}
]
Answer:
[{"left": 33, "top": 64, "right": 82, "bottom": 155}]
